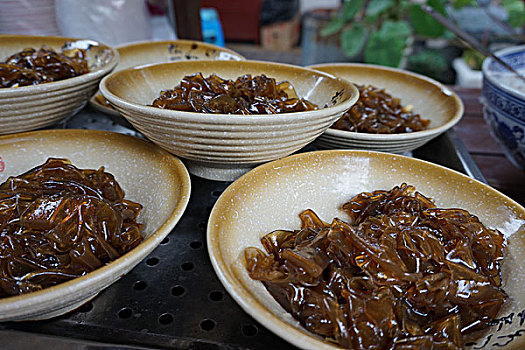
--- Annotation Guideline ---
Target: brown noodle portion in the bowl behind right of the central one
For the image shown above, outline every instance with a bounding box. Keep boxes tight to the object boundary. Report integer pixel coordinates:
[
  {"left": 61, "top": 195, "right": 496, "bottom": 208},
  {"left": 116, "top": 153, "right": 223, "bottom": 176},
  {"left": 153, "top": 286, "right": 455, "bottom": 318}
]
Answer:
[{"left": 331, "top": 84, "right": 430, "bottom": 134}]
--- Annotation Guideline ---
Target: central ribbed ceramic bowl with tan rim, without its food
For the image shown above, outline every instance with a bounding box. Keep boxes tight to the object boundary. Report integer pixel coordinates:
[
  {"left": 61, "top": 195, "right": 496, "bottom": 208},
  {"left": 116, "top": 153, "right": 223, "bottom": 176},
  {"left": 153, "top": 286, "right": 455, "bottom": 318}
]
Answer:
[{"left": 100, "top": 61, "right": 358, "bottom": 180}]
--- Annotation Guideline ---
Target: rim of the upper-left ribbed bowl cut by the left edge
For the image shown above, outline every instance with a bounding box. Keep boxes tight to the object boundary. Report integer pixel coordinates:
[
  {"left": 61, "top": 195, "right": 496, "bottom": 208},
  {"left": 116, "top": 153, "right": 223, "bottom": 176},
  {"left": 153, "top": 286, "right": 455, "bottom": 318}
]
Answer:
[{"left": 0, "top": 34, "right": 120, "bottom": 100}]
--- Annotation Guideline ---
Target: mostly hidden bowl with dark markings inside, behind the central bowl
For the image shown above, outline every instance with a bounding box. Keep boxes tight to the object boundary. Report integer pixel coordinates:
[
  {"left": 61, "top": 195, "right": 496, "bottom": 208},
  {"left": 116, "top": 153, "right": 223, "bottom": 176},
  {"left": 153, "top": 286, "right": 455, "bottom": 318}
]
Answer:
[{"left": 89, "top": 40, "right": 244, "bottom": 120}]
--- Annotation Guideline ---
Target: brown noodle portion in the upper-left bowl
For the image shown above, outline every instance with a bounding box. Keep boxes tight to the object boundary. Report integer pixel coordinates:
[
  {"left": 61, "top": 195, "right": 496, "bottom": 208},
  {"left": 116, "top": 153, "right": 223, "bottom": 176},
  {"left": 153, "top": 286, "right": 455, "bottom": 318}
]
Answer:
[{"left": 0, "top": 46, "right": 89, "bottom": 88}]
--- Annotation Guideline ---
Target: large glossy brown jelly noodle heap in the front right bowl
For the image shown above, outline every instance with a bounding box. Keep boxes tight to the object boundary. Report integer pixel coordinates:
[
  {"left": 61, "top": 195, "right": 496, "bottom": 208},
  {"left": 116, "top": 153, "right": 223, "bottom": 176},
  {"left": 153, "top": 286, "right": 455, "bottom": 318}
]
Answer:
[{"left": 244, "top": 184, "right": 507, "bottom": 349}]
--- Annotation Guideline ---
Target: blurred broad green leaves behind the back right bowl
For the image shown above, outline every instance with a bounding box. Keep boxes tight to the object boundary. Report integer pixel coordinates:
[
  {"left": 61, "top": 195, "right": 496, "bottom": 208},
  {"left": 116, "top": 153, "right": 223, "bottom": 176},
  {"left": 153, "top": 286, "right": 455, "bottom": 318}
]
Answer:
[{"left": 320, "top": 0, "right": 447, "bottom": 67}]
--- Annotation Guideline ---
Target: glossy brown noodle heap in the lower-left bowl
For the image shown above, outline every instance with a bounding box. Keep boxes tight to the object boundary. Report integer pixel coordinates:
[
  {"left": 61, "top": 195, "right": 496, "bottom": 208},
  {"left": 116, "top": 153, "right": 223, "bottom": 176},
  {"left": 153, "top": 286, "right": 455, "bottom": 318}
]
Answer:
[{"left": 0, "top": 158, "right": 143, "bottom": 298}]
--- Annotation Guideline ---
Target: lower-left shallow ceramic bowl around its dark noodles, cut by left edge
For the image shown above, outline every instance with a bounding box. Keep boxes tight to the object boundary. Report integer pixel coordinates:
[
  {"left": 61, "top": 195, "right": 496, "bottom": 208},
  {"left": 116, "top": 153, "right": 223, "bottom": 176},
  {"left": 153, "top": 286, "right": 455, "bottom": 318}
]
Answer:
[{"left": 0, "top": 130, "right": 190, "bottom": 321}]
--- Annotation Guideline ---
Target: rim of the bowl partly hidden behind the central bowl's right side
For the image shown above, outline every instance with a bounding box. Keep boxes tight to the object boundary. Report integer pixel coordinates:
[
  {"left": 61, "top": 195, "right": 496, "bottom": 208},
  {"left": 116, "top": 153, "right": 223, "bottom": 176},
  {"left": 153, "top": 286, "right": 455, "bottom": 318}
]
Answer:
[{"left": 308, "top": 62, "right": 465, "bottom": 141}]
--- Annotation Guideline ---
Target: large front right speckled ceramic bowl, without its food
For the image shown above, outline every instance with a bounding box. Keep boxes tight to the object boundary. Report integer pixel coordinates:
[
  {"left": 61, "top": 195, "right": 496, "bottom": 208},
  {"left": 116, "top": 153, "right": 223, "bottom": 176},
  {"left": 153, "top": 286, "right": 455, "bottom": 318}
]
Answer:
[{"left": 207, "top": 150, "right": 525, "bottom": 349}]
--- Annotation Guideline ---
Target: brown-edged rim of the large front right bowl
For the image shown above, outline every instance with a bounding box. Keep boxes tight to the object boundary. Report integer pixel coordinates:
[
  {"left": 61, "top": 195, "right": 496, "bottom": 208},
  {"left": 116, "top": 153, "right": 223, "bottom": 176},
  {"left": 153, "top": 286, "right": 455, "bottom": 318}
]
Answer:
[{"left": 206, "top": 149, "right": 525, "bottom": 349}]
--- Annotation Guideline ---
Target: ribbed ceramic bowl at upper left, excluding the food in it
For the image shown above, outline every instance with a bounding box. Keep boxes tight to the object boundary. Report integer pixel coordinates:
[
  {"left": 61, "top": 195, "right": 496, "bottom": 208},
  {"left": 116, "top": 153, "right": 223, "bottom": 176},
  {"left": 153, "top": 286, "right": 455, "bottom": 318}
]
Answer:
[{"left": 0, "top": 35, "right": 119, "bottom": 134}]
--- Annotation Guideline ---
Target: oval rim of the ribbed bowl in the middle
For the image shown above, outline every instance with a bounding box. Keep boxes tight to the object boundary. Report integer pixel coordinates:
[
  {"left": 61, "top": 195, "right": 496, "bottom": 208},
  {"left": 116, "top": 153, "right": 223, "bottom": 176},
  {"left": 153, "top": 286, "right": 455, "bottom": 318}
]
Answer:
[{"left": 99, "top": 60, "right": 359, "bottom": 121}]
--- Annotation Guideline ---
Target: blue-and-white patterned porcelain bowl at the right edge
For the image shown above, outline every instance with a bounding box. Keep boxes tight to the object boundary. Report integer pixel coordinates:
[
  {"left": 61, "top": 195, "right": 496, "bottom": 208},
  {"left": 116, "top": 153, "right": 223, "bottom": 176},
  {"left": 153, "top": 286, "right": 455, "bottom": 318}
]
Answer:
[{"left": 482, "top": 45, "right": 525, "bottom": 170}]
